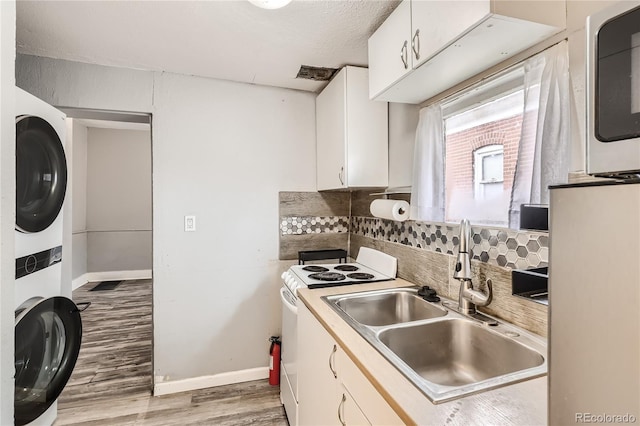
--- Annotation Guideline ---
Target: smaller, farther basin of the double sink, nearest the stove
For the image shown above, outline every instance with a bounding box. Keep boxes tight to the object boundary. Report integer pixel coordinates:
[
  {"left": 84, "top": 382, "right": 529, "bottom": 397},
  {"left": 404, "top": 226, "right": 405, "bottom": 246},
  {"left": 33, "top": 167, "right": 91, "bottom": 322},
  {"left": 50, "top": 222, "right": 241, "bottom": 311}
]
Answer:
[{"left": 335, "top": 289, "right": 447, "bottom": 327}]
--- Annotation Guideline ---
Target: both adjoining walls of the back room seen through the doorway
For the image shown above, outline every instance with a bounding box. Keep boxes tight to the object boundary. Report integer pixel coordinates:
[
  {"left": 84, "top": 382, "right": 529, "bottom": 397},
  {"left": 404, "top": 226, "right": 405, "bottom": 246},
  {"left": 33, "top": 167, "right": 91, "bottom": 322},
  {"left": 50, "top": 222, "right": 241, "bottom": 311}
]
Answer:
[{"left": 66, "top": 119, "right": 152, "bottom": 287}]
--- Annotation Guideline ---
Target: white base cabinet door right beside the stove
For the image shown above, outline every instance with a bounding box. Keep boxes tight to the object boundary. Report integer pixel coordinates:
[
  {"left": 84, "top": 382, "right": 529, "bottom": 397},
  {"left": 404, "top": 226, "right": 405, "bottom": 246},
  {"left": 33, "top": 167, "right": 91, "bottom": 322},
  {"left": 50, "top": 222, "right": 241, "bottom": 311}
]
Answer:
[{"left": 298, "top": 301, "right": 341, "bottom": 426}]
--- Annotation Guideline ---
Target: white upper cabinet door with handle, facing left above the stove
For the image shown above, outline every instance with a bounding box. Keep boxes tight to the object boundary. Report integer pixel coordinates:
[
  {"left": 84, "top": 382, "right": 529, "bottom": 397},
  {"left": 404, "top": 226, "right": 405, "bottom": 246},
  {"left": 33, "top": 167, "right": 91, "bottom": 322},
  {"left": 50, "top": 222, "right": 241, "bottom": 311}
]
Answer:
[{"left": 316, "top": 68, "right": 347, "bottom": 191}]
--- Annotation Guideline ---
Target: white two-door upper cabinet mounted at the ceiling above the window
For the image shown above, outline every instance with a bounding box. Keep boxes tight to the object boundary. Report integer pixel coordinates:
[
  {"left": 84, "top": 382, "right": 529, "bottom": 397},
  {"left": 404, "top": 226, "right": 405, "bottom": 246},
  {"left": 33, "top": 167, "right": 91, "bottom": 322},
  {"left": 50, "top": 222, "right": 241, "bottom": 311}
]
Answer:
[{"left": 369, "top": 0, "right": 566, "bottom": 104}]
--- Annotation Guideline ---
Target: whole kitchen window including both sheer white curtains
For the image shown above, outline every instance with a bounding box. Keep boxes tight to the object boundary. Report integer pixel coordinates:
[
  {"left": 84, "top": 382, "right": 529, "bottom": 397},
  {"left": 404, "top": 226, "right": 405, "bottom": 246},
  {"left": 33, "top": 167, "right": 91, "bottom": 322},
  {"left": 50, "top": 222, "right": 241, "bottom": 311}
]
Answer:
[{"left": 411, "top": 41, "right": 571, "bottom": 228}]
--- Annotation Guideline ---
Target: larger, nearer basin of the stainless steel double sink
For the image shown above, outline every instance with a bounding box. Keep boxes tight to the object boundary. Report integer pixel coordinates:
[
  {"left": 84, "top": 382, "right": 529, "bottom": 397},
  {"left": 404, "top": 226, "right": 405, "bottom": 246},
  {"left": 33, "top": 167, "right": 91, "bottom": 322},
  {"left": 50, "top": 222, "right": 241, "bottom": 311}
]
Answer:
[{"left": 378, "top": 319, "right": 544, "bottom": 386}]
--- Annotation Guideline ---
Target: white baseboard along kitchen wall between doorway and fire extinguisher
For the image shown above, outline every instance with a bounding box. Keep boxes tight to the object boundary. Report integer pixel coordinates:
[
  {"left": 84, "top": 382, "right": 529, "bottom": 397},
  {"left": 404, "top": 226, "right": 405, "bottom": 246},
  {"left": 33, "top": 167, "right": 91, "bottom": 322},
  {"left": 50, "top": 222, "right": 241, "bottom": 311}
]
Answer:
[{"left": 153, "top": 367, "right": 269, "bottom": 396}]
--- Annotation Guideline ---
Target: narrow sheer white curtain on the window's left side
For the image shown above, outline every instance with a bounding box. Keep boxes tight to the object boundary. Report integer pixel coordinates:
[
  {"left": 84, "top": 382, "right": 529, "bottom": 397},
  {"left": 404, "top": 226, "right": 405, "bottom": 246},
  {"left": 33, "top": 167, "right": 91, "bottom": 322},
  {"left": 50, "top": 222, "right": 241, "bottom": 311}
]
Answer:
[{"left": 410, "top": 103, "right": 444, "bottom": 222}]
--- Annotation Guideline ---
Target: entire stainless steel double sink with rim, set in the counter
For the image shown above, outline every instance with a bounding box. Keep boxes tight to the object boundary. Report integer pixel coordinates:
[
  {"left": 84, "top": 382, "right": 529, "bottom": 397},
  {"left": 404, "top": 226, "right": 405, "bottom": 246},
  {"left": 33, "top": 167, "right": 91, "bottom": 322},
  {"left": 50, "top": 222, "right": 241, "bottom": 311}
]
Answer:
[{"left": 322, "top": 287, "right": 547, "bottom": 403}]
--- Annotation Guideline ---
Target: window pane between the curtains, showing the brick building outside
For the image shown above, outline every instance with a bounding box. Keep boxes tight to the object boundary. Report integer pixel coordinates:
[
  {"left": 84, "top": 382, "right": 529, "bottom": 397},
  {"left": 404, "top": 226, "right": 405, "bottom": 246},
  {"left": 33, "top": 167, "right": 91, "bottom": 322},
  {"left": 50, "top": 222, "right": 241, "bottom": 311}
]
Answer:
[{"left": 443, "top": 73, "right": 533, "bottom": 227}]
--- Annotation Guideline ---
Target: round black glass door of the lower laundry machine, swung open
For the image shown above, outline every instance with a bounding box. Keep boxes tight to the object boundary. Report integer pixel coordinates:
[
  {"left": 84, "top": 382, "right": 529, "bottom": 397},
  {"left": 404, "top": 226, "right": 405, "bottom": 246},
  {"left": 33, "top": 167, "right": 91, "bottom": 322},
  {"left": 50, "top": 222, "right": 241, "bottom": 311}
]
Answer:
[{"left": 14, "top": 297, "right": 82, "bottom": 425}]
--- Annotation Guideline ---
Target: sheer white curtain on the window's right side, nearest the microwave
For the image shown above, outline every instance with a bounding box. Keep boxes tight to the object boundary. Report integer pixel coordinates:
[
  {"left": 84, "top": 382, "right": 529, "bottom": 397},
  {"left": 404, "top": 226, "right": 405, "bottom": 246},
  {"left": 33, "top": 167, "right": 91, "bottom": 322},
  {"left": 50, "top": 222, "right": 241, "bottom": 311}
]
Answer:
[{"left": 509, "top": 41, "right": 570, "bottom": 228}]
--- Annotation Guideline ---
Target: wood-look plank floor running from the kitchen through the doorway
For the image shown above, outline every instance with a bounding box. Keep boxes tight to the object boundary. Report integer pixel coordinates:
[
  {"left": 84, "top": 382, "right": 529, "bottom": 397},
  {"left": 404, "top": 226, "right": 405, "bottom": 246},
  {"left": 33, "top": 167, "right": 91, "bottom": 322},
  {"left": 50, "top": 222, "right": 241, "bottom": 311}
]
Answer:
[{"left": 55, "top": 280, "right": 287, "bottom": 426}]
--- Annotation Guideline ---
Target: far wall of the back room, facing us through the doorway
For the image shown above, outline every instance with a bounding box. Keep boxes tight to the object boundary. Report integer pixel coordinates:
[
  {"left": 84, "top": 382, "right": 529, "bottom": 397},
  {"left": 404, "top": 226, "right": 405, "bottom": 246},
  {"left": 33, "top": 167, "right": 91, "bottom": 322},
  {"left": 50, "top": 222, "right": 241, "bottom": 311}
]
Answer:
[{"left": 85, "top": 127, "right": 152, "bottom": 272}]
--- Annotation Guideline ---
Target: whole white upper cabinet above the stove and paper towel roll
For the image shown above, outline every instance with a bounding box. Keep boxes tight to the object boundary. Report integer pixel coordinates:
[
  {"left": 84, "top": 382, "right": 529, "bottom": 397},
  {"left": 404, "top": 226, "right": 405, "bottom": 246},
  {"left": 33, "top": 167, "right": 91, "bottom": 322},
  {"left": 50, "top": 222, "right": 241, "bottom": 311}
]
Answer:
[{"left": 316, "top": 66, "right": 389, "bottom": 191}]
